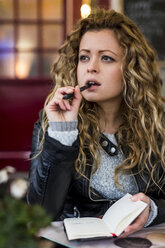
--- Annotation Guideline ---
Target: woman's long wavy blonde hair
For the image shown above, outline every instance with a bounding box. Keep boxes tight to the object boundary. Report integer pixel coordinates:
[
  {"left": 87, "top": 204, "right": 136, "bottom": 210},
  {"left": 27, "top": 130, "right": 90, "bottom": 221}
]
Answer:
[{"left": 41, "top": 9, "right": 165, "bottom": 190}]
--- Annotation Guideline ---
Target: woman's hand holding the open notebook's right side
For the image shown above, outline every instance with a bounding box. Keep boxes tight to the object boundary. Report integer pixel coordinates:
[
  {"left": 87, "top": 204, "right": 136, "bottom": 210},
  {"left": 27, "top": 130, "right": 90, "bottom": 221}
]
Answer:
[{"left": 120, "top": 193, "right": 150, "bottom": 238}]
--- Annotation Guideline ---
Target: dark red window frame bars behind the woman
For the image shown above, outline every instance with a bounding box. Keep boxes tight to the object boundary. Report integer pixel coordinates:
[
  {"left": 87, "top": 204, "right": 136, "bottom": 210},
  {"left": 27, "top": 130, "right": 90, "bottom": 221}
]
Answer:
[{"left": 0, "top": 0, "right": 67, "bottom": 79}]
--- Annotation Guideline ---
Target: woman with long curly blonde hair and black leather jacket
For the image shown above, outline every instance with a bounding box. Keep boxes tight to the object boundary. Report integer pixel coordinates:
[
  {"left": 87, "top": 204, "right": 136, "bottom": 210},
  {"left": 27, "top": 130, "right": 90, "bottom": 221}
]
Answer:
[{"left": 28, "top": 9, "right": 165, "bottom": 236}]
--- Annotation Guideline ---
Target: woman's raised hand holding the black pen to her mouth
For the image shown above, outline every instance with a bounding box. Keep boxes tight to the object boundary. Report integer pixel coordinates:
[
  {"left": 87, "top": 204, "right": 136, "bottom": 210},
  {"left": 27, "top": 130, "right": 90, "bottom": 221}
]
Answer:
[{"left": 45, "top": 86, "right": 82, "bottom": 121}]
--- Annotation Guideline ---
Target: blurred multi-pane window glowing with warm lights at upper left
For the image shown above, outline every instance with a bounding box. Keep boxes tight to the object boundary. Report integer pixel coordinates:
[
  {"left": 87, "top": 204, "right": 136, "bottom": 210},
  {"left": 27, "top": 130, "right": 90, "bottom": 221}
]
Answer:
[{"left": 0, "top": 0, "right": 66, "bottom": 79}]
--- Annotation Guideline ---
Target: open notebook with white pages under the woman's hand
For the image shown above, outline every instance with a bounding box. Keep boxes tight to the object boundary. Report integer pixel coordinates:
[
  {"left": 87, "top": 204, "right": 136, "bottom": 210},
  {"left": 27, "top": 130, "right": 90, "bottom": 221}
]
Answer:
[{"left": 64, "top": 193, "right": 147, "bottom": 240}]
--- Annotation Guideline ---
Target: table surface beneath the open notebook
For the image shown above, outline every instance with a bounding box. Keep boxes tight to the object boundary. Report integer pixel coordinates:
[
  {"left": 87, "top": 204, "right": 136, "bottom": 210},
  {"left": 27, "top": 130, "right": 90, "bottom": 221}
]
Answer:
[{"left": 38, "top": 221, "right": 165, "bottom": 248}]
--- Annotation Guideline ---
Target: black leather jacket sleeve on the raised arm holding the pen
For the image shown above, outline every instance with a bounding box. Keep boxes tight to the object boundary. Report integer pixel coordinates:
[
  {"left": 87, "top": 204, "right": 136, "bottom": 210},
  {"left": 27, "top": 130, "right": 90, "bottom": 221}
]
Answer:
[{"left": 27, "top": 116, "right": 79, "bottom": 220}]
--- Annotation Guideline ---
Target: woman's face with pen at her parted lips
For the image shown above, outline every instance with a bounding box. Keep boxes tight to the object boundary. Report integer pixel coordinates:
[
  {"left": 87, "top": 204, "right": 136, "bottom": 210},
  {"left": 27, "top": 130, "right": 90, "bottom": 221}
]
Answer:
[{"left": 77, "top": 29, "right": 123, "bottom": 104}]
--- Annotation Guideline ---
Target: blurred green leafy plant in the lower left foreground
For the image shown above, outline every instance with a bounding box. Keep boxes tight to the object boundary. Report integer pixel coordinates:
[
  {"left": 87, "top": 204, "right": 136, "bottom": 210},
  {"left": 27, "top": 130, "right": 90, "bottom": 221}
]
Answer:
[{"left": 0, "top": 167, "right": 51, "bottom": 248}]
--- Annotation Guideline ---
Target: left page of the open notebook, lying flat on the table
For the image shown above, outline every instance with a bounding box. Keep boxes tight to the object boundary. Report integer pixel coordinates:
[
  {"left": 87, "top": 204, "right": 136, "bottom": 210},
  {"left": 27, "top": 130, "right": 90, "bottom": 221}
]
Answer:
[{"left": 64, "top": 217, "right": 112, "bottom": 240}]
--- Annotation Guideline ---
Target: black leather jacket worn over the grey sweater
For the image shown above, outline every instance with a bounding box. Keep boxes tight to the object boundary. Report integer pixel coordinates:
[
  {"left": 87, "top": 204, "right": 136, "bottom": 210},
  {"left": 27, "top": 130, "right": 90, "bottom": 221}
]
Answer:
[{"left": 27, "top": 112, "right": 165, "bottom": 227}]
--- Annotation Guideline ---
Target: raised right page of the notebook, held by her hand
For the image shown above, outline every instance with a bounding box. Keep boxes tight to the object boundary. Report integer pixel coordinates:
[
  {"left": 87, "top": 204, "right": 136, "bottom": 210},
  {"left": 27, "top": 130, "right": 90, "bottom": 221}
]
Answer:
[{"left": 103, "top": 193, "right": 147, "bottom": 236}]
